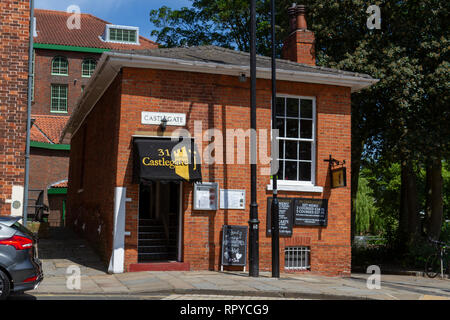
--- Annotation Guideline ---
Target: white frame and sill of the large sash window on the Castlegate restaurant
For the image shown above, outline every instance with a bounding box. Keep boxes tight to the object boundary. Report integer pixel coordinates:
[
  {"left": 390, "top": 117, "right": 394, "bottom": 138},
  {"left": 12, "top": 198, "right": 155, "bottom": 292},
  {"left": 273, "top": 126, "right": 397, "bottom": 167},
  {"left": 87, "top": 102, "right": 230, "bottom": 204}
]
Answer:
[{"left": 267, "top": 94, "right": 323, "bottom": 193}]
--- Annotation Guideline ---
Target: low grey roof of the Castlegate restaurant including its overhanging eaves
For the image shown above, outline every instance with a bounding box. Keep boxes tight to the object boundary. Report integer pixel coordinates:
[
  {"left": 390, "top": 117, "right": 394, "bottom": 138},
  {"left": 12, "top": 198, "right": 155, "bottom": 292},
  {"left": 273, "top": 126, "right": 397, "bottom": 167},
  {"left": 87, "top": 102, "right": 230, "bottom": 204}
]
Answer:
[{"left": 60, "top": 46, "right": 379, "bottom": 143}]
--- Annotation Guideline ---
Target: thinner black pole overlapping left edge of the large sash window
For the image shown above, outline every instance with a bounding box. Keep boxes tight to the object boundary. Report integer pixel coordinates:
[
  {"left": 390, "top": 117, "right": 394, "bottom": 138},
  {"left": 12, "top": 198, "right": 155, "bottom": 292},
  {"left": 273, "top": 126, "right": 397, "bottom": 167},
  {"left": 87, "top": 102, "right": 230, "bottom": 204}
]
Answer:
[{"left": 271, "top": 0, "right": 280, "bottom": 278}]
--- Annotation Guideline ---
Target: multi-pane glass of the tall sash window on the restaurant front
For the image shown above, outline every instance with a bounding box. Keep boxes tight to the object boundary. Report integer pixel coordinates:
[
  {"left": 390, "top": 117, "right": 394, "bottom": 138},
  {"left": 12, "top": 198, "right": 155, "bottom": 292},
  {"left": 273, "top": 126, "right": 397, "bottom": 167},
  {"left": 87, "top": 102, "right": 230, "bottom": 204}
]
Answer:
[{"left": 276, "top": 96, "right": 315, "bottom": 184}]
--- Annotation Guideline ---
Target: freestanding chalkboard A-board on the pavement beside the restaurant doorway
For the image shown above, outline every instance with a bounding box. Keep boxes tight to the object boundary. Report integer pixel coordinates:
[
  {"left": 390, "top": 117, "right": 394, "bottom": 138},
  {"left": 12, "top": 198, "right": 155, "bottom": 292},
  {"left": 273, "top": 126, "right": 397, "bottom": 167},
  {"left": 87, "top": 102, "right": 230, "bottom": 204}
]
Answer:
[{"left": 222, "top": 225, "right": 247, "bottom": 266}]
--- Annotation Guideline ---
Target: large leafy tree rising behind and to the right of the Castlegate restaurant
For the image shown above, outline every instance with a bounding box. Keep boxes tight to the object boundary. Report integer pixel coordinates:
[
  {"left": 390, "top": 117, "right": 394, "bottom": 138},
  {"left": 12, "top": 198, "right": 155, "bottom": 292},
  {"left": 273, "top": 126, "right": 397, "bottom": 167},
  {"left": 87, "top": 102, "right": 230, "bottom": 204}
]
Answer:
[{"left": 150, "top": 0, "right": 450, "bottom": 245}]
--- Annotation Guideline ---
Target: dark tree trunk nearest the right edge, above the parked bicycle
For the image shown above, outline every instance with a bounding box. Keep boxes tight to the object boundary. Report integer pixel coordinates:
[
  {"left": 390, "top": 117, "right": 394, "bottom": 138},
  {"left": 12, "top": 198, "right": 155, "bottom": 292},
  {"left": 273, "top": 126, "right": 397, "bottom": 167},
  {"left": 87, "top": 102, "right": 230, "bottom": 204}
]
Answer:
[{"left": 428, "top": 159, "right": 444, "bottom": 239}]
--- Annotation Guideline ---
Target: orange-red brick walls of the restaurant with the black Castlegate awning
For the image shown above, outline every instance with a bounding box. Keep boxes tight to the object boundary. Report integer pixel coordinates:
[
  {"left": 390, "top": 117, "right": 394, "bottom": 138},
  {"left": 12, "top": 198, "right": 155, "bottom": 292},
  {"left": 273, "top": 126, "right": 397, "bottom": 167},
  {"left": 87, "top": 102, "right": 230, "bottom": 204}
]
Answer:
[{"left": 69, "top": 68, "right": 351, "bottom": 275}]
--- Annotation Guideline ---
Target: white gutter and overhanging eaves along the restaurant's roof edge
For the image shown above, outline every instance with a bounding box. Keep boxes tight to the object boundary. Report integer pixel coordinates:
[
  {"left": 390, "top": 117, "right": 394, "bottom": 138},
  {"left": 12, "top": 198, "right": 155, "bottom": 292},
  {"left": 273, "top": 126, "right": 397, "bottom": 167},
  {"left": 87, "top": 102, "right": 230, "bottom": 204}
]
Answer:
[{"left": 60, "top": 52, "right": 379, "bottom": 143}]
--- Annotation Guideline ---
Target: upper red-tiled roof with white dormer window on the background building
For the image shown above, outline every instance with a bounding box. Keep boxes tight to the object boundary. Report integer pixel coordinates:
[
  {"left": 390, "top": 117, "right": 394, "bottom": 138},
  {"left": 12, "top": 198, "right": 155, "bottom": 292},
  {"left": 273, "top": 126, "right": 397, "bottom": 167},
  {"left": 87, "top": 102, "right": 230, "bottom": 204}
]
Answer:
[{"left": 34, "top": 9, "right": 158, "bottom": 50}]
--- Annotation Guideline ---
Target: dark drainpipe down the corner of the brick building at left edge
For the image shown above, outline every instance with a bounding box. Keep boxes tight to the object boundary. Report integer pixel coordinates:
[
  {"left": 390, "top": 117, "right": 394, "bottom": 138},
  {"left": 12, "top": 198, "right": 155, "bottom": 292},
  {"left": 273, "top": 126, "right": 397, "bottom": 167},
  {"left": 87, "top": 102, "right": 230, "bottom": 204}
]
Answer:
[{"left": 22, "top": 0, "right": 34, "bottom": 226}]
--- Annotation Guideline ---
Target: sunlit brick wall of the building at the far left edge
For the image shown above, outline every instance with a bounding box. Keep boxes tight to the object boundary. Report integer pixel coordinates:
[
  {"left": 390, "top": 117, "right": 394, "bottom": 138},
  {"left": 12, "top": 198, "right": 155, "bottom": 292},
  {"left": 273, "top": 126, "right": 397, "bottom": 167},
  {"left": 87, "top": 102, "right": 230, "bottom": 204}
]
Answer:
[{"left": 0, "top": 0, "right": 30, "bottom": 215}]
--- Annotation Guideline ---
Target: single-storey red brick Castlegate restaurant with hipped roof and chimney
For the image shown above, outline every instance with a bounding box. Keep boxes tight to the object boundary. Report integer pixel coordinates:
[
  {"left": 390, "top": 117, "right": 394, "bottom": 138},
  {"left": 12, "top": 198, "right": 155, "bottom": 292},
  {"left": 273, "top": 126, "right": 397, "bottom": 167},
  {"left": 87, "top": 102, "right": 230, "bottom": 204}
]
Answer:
[{"left": 63, "top": 5, "right": 376, "bottom": 275}]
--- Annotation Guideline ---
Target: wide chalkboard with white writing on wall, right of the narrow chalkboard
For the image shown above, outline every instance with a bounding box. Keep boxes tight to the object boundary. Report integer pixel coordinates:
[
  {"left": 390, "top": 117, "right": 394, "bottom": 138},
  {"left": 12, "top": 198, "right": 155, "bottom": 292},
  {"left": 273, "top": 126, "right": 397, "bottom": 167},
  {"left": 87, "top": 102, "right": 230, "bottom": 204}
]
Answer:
[{"left": 294, "top": 198, "right": 328, "bottom": 226}]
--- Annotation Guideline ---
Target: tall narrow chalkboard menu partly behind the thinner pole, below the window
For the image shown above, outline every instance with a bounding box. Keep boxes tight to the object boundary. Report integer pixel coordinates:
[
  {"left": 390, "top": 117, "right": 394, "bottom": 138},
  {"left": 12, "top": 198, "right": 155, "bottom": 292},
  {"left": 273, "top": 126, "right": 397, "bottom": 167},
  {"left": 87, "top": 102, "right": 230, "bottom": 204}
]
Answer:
[{"left": 266, "top": 197, "right": 294, "bottom": 237}]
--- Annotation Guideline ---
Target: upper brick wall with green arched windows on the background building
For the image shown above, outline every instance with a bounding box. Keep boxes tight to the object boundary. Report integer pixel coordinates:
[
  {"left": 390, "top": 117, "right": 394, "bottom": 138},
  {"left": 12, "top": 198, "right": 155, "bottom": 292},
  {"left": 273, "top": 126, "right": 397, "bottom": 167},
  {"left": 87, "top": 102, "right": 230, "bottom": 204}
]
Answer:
[{"left": 33, "top": 49, "right": 100, "bottom": 115}]
